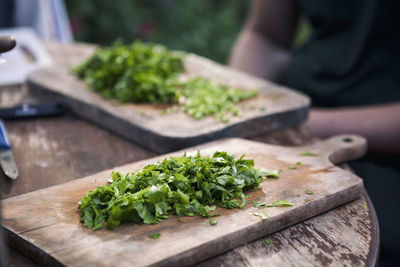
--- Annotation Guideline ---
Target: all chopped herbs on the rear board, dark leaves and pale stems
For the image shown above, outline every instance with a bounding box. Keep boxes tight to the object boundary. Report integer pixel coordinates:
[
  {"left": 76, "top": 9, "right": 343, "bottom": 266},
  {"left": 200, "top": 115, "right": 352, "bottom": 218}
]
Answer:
[{"left": 73, "top": 41, "right": 258, "bottom": 121}]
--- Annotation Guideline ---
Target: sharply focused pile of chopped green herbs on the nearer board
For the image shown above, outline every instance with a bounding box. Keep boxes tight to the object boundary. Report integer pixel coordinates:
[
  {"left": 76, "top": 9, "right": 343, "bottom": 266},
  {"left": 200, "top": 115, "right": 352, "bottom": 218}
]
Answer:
[{"left": 79, "top": 152, "right": 279, "bottom": 230}]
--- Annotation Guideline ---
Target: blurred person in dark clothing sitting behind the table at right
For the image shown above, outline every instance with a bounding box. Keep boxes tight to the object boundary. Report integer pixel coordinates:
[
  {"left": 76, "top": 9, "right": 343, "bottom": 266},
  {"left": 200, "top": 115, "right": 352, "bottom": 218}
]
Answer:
[{"left": 229, "top": 0, "right": 400, "bottom": 266}]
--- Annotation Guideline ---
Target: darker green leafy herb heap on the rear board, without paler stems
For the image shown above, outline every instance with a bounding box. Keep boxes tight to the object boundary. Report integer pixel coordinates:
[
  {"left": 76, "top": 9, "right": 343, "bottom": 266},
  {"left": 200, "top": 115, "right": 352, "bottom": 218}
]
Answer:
[{"left": 73, "top": 41, "right": 184, "bottom": 103}]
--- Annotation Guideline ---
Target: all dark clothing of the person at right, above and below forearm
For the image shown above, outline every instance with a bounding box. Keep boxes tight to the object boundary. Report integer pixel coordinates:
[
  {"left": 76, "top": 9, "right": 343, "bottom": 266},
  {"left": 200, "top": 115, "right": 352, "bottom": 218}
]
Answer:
[{"left": 285, "top": 0, "right": 400, "bottom": 266}]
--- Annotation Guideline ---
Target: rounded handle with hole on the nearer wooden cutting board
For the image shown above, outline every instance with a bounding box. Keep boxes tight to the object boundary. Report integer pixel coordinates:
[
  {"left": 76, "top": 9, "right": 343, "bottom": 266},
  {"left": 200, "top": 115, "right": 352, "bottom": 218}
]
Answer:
[{"left": 322, "top": 134, "right": 367, "bottom": 164}]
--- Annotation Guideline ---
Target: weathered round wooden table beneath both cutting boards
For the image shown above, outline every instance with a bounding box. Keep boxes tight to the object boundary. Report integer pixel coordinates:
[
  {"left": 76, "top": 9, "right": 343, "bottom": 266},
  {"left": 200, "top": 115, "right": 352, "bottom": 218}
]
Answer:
[{"left": 0, "top": 43, "right": 379, "bottom": 266}]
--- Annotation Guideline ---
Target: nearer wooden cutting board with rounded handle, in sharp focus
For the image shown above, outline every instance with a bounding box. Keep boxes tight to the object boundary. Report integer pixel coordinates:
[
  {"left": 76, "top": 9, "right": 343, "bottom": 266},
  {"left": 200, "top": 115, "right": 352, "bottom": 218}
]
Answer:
[{"left": 2, "top": 135, "right": 366, "bottom": 266}]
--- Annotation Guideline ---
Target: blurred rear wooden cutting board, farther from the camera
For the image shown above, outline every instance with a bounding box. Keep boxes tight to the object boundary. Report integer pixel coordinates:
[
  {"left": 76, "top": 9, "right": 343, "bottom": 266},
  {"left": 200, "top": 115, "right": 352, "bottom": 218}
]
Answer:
[{"left": 27, "top": 51, "right": 310, "bottom": 153}]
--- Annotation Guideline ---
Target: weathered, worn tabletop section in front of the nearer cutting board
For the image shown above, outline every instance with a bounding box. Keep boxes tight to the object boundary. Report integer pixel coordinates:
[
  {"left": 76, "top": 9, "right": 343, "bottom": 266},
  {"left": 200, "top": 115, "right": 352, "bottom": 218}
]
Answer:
[{"left": 198, "top": 195, "right": 377, "bottom": 267}]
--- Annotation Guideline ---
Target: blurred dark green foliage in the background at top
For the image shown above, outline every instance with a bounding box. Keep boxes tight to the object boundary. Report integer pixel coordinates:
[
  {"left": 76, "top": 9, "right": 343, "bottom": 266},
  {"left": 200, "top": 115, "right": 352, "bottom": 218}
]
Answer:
[{"left": 66, "top": 0, "right": 250, "bottom": 63}]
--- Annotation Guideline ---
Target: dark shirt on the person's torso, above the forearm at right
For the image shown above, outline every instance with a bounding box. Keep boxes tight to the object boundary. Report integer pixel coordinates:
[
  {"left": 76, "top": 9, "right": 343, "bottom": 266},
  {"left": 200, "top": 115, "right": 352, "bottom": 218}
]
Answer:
[{"left": 286, "top": 0, "right": 400, "bottom": 107}]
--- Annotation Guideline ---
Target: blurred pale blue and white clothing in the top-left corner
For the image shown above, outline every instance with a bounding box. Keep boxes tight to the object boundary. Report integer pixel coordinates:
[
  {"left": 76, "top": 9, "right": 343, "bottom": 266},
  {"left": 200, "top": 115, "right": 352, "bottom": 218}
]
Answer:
[{"left": 0, "top": 0, "right": 73, "bottom": 43}]
